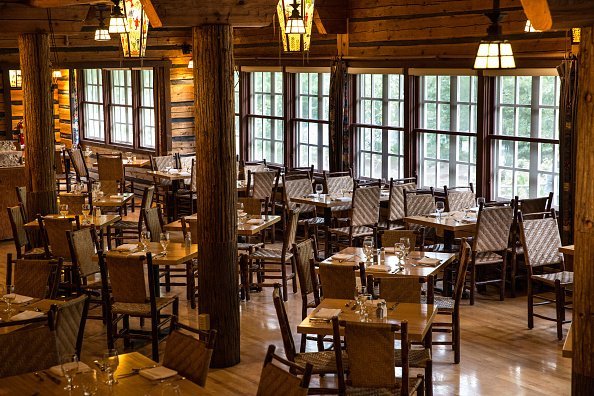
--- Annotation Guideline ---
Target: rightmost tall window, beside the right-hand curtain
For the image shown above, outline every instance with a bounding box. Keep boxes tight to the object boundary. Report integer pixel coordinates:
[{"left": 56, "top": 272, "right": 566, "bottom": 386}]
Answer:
[{"left": 493, "top": 76, "right": 560, "bottom": 204}]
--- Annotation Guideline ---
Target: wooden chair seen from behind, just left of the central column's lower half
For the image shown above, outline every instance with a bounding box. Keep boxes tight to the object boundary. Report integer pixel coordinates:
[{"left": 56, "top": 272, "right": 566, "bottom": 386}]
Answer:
[{"left": 98, "top": 252, "right": 179, "bottom": 362}]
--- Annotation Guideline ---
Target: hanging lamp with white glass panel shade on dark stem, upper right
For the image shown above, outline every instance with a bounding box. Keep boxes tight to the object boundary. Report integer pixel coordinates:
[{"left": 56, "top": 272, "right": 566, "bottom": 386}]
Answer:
[{"left": 474, "top": 0, "right": 516, "bottom": 69}]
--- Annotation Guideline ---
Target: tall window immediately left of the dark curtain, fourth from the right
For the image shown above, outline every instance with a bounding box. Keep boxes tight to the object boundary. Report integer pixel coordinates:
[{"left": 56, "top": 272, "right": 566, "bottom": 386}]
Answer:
[{"left": 293, "top": 73, "right": 330, "bottom": 170}]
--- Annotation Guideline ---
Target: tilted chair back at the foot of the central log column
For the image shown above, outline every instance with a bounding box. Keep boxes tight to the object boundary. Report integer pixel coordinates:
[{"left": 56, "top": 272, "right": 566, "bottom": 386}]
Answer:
[{"left": 163, "top": 317, "right": 217, "bottom": 387}]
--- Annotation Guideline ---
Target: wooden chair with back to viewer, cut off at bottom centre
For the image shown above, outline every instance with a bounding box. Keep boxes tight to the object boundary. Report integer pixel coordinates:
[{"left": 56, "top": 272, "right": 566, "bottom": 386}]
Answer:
[{"left": 332, "top": 318, "right": 424, "bottom": 396}]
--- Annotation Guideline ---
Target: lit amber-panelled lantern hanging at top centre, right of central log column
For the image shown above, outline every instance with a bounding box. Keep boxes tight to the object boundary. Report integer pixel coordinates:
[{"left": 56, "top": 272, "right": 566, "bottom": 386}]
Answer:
[{"left": 276, "top": 0, "right": 314, "bottom": 52}]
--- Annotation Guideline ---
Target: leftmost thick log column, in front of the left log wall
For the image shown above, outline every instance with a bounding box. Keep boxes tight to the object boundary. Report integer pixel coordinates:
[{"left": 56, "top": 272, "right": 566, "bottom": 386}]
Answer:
[{"left": 19, "top": 33, "right": 57, "bottom": 215}]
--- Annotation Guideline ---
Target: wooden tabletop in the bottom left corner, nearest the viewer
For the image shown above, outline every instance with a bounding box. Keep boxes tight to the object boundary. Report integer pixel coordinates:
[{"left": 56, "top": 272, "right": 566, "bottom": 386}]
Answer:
[{"left": 0, "top": 352, "right": 216, "bottom": 396}]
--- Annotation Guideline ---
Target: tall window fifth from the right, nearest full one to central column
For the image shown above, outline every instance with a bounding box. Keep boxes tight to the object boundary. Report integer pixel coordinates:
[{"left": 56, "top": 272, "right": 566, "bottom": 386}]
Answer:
[{"left": 248, "top": 72, "right": 285, "bottom": 164}]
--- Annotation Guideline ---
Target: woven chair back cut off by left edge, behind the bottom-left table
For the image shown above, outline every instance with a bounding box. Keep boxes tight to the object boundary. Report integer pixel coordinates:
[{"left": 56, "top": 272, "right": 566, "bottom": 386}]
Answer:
[{"left": 0, "top": 326, "right": 59, "bottom": 380}]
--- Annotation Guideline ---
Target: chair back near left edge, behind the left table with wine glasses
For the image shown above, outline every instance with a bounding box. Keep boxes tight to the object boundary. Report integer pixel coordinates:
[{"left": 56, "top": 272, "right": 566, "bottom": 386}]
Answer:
[{"left": 6, "top": 253, "right": 62, "bottom": 299}]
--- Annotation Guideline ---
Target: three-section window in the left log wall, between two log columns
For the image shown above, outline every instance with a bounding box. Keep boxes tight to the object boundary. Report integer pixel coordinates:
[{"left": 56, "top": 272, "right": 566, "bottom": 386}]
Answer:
[{"left": 80, "top": 69, "right": 156, "bottom": 150}]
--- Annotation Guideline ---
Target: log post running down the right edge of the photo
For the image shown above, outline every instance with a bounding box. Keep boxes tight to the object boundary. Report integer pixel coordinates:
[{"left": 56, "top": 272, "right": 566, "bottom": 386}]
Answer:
[{"left": 571, "top": 27, "right": 594, "bottom": 395}]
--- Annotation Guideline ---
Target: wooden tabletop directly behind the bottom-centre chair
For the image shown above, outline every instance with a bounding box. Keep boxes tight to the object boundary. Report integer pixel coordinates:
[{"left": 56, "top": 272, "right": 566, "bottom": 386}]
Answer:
[{"left": 297, "top": 298, "right": 437, "bottom": 347}]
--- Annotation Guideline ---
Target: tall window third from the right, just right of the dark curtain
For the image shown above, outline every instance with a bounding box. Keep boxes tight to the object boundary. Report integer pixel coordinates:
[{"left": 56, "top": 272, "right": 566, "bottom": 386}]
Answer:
[{"left": 353, "top": 74, "right": 404, "bottom": 179}]
